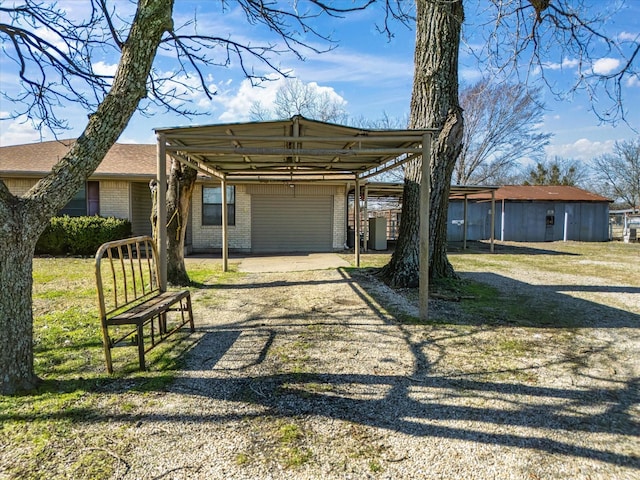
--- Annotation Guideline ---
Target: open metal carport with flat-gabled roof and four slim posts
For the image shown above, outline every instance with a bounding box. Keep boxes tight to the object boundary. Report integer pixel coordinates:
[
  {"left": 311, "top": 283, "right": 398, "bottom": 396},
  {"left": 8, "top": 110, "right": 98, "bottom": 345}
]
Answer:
[{"left": 155, "top": 115, "right": 437, "bottom": 319}]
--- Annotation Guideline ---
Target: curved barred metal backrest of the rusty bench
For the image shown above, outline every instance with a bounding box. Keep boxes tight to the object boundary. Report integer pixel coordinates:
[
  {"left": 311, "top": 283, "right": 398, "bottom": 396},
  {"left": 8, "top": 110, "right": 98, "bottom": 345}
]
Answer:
[{"left": 95, "top": 236, "right": 162, "bottom": 321}]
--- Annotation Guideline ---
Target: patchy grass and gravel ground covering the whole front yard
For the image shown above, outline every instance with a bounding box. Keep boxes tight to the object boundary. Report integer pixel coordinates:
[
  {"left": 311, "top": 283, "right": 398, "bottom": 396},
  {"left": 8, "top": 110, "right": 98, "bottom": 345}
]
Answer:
[{"left": 0, "top": 243, "right": 640, "bottom": 480}]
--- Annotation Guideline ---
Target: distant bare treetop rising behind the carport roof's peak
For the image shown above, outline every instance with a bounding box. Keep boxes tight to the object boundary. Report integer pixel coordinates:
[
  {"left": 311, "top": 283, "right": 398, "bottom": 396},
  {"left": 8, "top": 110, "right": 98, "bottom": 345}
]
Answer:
[{"left": 251, "top": 78, "right": 348, "bottom": 123}]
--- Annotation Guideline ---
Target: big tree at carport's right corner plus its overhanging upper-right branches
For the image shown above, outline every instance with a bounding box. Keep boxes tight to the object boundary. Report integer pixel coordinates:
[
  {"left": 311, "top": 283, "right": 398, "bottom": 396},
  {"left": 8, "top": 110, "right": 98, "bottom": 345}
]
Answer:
[{"left": 381, "top": 0, "right": 640, "bottom": 286}]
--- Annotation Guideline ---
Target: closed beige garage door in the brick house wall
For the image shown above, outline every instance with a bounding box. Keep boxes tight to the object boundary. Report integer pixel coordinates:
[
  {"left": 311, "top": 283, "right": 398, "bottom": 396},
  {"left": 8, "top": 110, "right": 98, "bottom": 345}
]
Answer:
[{"left": 251, "top": 195, "right": 333, "bottom": 253}]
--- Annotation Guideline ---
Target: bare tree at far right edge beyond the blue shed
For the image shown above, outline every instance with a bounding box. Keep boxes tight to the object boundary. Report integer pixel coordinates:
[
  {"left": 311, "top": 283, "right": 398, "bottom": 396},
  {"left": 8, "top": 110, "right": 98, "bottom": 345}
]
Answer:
[{"left": 592, "top": 137, "right": 640, "bottom": 208}]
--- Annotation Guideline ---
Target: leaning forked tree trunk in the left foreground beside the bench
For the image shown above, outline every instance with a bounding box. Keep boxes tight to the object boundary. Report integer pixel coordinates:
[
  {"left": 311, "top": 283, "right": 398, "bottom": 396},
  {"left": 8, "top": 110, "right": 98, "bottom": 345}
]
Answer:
[{"left": 0, "top": 0, "right": 173, "bottom": 394}]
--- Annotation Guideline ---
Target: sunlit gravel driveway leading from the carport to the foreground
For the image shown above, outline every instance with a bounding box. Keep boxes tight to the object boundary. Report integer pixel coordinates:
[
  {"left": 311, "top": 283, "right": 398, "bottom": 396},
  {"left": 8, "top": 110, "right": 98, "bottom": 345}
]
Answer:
[{"left": 105, "top": 270, "right": 640, "bottom": 480}]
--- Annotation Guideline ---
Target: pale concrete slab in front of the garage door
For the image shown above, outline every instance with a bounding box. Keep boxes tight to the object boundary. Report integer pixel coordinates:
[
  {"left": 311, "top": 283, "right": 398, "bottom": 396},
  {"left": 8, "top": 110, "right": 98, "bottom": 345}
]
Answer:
[{"left": 238, "top": 253, "right": 350, "bottom": 273}]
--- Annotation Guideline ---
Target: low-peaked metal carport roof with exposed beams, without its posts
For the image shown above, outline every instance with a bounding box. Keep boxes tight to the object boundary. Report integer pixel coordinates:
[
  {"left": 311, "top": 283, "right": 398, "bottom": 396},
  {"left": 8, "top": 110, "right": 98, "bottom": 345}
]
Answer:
[{"left": 155, "top": 115, "right": 437, "bottom": 182}]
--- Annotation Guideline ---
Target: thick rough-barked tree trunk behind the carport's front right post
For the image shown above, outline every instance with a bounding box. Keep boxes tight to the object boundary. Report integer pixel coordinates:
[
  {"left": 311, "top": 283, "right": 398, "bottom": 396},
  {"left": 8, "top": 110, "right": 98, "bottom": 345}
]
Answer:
[{"left": 381, "top": 0, "right": 464, "bottom": 287}]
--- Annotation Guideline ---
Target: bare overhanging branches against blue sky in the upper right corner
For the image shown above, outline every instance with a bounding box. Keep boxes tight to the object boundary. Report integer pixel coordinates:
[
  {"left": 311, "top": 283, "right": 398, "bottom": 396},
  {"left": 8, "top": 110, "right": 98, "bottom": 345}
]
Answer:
[{"left": 476, "top": 0, "right": 640, "bottom": 123}]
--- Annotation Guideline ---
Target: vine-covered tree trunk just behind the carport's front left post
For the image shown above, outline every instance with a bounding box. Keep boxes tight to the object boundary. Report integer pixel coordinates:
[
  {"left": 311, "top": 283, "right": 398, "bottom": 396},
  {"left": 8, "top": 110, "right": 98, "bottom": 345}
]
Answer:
[{"left": 151, "top": 160, "right": 198, "bottom": 286}]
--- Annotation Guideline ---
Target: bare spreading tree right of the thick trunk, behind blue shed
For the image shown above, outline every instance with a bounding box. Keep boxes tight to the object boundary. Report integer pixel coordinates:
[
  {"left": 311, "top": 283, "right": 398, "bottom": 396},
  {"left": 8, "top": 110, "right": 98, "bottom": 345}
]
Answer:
[{"left": 453, "top": 80, "right": 551, "bottom": 185}]
